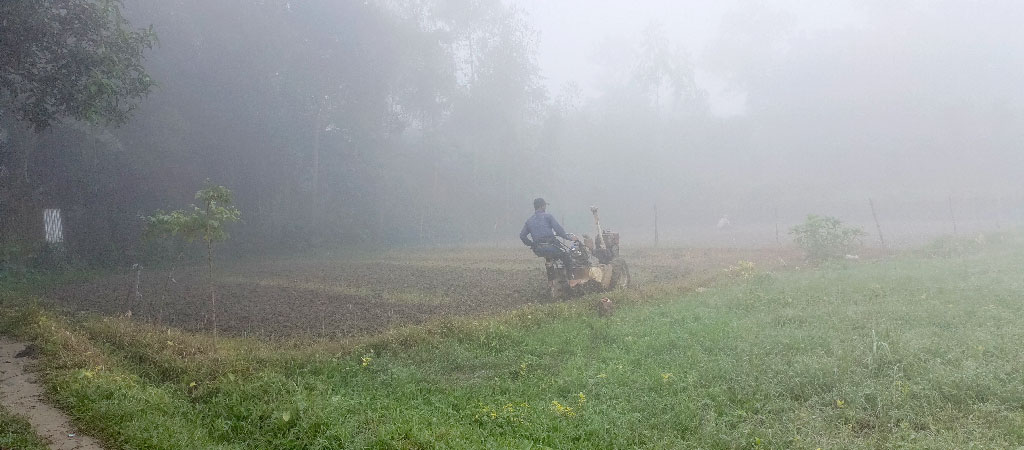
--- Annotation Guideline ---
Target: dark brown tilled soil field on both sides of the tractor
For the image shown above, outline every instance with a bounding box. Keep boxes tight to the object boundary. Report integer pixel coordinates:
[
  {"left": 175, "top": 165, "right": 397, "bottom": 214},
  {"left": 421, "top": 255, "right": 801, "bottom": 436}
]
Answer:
[{"left": 45, "top": 249, "right": 801, "bottom": 336}]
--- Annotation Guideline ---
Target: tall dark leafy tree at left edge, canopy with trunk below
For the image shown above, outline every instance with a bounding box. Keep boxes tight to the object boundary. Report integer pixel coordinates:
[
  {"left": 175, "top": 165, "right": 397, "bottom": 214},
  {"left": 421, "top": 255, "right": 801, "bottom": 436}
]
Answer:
[{"left": 0, "top": 0, "right": 156, "bottom": 259}]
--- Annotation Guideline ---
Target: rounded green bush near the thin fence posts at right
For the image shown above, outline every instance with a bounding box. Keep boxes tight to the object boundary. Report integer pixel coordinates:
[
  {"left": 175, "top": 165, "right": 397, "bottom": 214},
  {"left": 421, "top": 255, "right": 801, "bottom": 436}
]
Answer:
[{"left": 790, "top": 214, "right": 865, "bottom": 262}]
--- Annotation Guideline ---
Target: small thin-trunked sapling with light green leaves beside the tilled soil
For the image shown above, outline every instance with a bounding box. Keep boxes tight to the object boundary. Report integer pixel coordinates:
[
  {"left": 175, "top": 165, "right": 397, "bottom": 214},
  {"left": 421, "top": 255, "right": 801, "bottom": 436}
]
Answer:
[{"left": 143, "top": 185, "right": 242, "bottom": 339}]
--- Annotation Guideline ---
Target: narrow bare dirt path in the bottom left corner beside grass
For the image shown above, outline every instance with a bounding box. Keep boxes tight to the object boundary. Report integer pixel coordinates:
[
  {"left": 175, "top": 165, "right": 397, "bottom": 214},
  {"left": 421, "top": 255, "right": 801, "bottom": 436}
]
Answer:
[{"left": 0, "top": 337, "right": 103, "bottom": 450}]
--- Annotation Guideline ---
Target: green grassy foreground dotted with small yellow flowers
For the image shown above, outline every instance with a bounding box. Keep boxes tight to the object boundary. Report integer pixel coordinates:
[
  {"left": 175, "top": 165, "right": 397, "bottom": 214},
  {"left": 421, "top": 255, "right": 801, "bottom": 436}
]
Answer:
[{"left": 0, "top": 236, "right": 1024, "bottom": 449}]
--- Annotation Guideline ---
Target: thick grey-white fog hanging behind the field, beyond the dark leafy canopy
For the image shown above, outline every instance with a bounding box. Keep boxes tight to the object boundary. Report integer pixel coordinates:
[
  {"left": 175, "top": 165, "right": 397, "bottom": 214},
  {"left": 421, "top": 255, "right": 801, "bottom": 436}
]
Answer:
[{"left": 0, "top": 0, "right": 1024, "bottom": 262}]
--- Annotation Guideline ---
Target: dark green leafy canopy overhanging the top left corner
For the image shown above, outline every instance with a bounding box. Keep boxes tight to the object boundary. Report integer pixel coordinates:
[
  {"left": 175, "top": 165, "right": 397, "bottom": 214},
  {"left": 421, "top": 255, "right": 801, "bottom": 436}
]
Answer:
[{"left": 0, "top": 0, "right": 156, "bottom": 131}]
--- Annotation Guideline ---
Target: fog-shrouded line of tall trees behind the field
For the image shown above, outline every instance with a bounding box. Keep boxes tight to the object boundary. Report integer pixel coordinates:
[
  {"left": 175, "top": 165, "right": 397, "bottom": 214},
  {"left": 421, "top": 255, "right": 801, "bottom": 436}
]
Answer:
[{"left": 6, "top": 0, "right": 1020, "bottom": 262}]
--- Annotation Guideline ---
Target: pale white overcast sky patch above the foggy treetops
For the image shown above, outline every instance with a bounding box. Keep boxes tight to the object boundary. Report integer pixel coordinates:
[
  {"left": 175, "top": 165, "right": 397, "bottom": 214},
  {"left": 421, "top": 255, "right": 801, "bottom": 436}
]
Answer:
[{"left": 509, "top": 0, "right": 863, "bottom": 116}]
